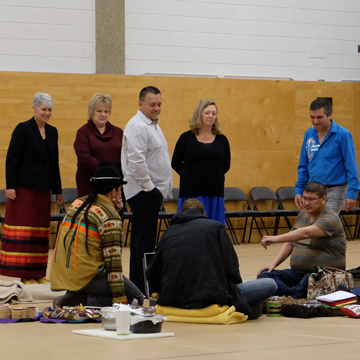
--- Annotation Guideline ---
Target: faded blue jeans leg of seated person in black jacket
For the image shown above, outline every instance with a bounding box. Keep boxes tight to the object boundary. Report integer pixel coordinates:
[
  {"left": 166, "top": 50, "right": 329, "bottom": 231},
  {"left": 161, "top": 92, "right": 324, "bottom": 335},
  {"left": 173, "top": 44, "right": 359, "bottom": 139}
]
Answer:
[{"left": 236, "top": 279, "right": 277, "bottom": 305}]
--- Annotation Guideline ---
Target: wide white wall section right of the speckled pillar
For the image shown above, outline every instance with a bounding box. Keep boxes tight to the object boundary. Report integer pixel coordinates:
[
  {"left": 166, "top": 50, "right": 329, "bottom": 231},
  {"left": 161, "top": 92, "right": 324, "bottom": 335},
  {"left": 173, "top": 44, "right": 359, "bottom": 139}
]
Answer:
[{"left": 125, "top": 0, "right": 360, "bottom": 81}]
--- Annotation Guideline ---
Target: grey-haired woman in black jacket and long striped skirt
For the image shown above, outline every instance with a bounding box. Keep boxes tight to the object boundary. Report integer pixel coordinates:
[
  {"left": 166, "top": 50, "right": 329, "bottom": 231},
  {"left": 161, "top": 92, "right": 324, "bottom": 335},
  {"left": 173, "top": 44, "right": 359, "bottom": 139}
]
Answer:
[{"left": 0, "top": 93, "right": 63, "bottom": 284}]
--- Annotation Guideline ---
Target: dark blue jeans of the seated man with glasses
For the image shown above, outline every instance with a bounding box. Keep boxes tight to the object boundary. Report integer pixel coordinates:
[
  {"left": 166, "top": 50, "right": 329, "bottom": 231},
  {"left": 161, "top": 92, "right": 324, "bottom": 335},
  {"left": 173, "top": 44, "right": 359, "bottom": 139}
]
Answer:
[{"left": 258, "top": 269, "right": 310, "bottom": 299}]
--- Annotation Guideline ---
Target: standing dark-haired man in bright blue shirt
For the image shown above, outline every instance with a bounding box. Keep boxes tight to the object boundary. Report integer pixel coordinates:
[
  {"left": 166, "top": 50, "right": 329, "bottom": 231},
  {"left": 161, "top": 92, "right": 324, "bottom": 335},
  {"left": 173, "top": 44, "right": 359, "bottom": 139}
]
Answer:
[{"left": 295, "top": 98, "right": 360, "bottom": 214}]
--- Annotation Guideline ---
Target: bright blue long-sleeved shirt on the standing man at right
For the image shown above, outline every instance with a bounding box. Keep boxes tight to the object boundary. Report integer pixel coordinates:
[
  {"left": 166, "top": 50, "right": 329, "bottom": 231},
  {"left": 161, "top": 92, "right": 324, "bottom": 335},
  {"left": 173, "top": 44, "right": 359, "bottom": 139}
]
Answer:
[{"left": 296, "top": 120, "right": 360, "bottom": 200}]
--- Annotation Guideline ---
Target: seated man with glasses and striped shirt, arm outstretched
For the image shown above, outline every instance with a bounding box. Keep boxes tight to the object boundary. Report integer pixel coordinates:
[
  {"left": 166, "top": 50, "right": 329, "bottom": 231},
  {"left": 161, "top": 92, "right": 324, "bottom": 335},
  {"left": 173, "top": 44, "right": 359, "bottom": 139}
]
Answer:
[{"left": 257, "top": 181, "right": 346, "bottom": 299}]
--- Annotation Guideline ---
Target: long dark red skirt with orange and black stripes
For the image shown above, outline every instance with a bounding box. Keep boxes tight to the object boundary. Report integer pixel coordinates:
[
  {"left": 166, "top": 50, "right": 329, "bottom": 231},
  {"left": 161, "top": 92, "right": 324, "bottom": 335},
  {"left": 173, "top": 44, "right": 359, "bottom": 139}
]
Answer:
[{"left": 0, "top": 187, "right": 51, "bottom": 279}]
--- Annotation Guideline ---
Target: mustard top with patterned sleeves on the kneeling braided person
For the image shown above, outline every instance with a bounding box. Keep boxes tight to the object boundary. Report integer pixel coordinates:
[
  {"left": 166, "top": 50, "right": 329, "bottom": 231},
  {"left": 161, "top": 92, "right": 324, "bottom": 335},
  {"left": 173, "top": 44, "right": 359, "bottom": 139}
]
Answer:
[{"left": 50, "top": 194, "right": 126, "bottom": 302}]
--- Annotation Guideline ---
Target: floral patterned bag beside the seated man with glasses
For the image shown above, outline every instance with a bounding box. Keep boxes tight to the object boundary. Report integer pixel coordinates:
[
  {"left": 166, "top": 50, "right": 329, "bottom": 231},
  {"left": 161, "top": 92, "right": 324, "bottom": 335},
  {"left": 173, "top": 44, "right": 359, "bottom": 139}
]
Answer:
[{"left": 307, "top": 266, "right": 354, "bottom": 300}]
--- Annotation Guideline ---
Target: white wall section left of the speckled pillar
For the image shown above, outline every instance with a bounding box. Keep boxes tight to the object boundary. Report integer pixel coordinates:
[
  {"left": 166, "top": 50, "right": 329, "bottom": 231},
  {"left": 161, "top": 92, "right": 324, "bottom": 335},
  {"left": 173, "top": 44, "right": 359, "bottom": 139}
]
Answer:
[{"left": 0, "top": 0, "right": 95, "bottom": 73}]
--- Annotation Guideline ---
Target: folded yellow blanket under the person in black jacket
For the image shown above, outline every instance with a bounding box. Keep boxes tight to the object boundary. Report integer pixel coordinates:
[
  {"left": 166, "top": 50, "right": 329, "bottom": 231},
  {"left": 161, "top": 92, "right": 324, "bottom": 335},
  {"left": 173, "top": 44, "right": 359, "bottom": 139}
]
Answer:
[{"left": 155, "top": 305, "right": 247, "bottom": 325}]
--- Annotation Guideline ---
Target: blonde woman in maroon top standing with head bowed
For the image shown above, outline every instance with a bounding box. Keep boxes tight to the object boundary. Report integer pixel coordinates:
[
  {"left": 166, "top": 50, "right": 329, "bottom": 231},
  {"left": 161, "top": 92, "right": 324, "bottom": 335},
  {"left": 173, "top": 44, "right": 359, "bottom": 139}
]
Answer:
[{"left": 74, "top": 94, "right": 123, "bottom": 197}]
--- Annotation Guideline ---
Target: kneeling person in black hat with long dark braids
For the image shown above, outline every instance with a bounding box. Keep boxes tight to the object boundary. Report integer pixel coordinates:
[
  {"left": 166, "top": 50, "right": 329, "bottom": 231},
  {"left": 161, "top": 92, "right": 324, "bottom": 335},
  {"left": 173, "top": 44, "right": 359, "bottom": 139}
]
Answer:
[{"left": 50, "top": 166, "right": 144, "bottom": 307}]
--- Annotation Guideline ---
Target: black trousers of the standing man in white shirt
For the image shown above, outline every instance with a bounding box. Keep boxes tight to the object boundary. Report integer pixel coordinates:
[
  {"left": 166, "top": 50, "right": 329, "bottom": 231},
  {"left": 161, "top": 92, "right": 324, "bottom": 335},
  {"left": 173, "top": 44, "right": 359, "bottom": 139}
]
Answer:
[{"left": 128, "top": 188, "right": 163, "bottom": 293}]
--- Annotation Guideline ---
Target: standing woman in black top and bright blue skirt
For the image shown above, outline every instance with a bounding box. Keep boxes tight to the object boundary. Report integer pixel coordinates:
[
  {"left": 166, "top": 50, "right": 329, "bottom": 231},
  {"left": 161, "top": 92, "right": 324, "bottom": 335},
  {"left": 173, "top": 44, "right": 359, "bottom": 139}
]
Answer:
[{"left": 172, "top": 99, "right": 231, "bottom": 225}]
